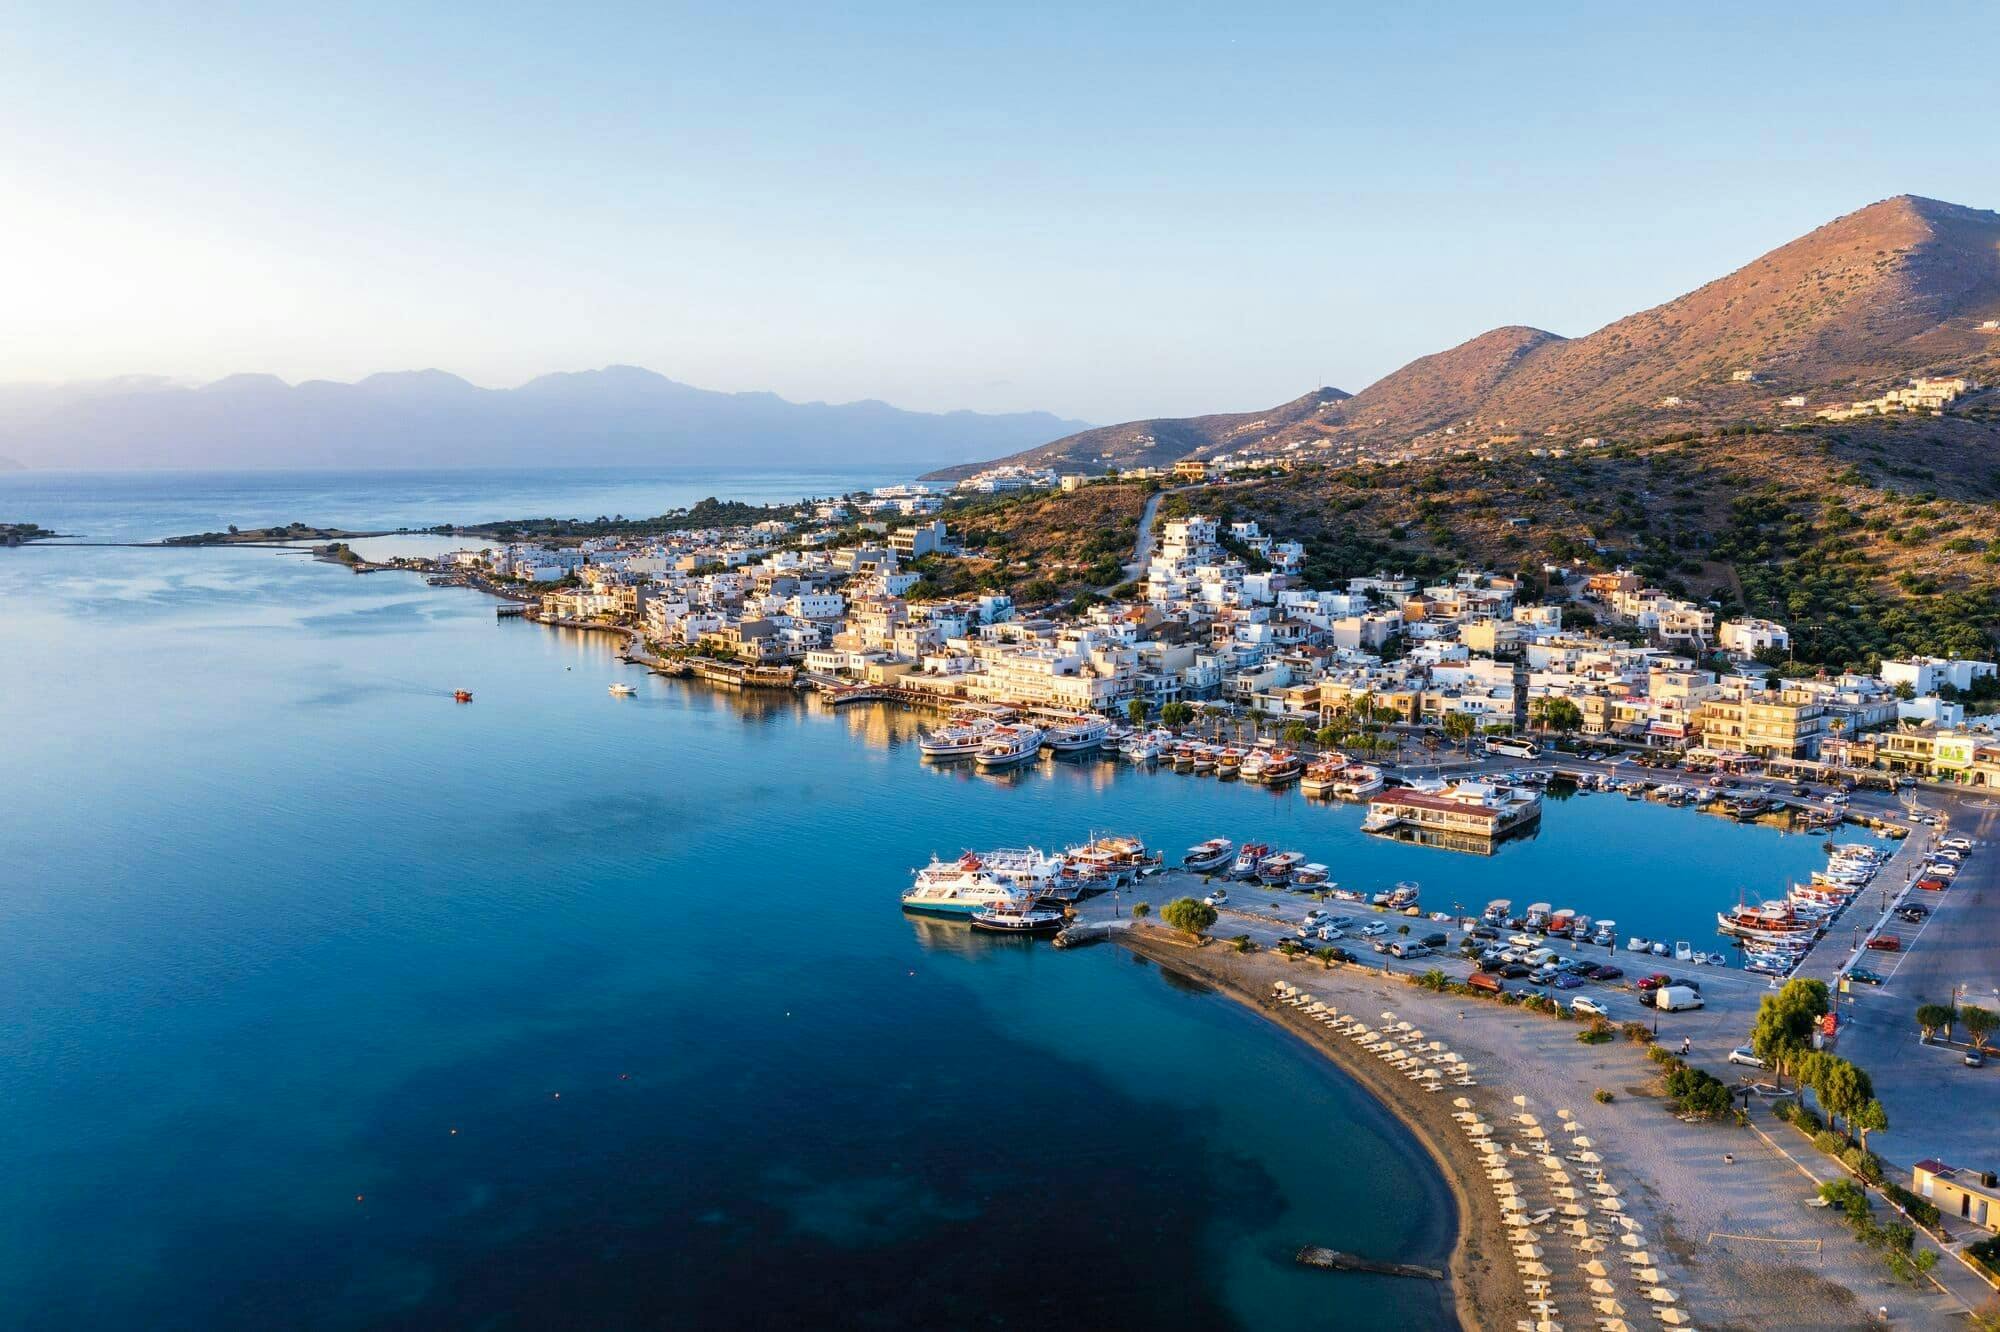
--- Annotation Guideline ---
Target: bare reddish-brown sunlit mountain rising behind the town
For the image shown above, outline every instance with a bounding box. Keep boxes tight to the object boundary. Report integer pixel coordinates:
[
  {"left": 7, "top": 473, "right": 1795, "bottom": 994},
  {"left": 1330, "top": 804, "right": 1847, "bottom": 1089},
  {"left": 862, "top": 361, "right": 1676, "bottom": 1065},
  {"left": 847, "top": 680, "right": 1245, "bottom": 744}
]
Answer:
[{"left": 932, "top": 194, "right": 2000, "bottom": 474}]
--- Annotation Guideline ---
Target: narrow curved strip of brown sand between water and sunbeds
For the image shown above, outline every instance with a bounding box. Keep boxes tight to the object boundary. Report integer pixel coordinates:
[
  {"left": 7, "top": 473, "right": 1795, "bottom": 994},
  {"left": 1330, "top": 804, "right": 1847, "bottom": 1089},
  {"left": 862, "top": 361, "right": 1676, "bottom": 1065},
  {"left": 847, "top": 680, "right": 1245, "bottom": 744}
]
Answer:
[{"left": 1112, "top": 924, "right": 1530, "bottom": 1330}]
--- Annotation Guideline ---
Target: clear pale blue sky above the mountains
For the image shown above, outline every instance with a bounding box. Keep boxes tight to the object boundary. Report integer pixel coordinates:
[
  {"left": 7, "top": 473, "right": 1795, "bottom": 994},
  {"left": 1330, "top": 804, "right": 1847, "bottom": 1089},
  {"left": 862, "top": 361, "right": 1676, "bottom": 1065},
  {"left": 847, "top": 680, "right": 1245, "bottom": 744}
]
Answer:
[{"left": 0, "top": 0, "right": 2000, "bottom": 422}]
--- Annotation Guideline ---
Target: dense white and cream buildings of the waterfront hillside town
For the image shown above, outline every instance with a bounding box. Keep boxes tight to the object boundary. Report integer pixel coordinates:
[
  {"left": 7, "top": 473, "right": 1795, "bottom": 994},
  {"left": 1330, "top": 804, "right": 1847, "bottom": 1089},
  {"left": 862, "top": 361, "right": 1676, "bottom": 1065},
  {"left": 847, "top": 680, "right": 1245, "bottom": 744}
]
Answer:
[{"left": 434, "top": 472, "right": 2000, "bottom": 784}]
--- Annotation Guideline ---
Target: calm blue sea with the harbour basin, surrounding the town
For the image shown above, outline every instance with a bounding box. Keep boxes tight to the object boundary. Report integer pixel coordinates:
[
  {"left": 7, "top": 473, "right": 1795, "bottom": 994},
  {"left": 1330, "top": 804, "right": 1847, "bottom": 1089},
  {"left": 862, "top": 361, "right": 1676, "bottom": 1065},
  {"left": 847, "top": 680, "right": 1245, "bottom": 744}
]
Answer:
[{"left": 0, "top": 470, "right": 1856, "bottom": 1328}]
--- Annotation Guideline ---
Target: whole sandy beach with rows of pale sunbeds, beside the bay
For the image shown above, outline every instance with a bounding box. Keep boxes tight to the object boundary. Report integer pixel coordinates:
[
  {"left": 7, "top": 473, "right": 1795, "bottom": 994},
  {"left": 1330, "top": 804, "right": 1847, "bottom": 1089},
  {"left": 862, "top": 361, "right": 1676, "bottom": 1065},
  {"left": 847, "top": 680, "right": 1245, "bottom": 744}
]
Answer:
[{"left": 1120, "top": 926, "right": 1962, "bottom": 1332}]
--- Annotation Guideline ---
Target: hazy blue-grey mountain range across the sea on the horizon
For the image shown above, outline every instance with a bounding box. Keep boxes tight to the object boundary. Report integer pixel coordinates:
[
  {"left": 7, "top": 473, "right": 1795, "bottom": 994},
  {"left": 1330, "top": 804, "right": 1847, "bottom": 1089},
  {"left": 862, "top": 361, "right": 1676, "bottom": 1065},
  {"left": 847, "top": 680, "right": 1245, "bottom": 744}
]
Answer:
[{"left": 0, "top": 366, "right": 1084, "bottom": 468}]
